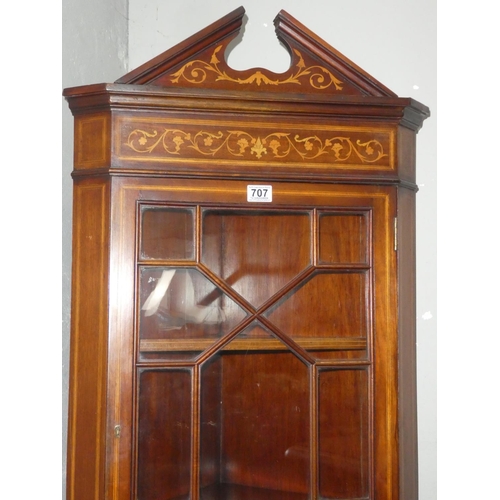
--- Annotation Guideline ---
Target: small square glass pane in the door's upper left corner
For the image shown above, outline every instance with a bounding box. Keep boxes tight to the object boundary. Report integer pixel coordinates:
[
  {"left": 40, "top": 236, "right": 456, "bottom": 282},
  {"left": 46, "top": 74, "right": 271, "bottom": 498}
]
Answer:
[{"left": 141, "top": 207, "right": 194, "bottom": 260}]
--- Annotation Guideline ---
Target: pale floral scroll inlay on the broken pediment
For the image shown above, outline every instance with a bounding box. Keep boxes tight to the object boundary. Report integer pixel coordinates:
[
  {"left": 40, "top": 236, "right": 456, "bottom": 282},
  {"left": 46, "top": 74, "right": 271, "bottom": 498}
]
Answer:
[{"left": 170, "top": 45, "right": 342, "bottom": 90}]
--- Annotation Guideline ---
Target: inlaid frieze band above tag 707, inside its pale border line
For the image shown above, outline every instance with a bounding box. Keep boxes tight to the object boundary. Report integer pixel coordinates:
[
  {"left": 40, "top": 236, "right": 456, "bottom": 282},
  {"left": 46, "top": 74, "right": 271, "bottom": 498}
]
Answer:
[{"left": 123, "top": 126, "right": 392, "bottom": 166}]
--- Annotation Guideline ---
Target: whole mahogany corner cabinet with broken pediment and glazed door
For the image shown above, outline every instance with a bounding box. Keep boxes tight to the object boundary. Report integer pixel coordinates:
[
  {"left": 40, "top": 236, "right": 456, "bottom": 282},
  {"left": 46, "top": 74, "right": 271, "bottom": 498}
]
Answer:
[{"left": 64, "top": 8, "right": 429, "bottom": 500}]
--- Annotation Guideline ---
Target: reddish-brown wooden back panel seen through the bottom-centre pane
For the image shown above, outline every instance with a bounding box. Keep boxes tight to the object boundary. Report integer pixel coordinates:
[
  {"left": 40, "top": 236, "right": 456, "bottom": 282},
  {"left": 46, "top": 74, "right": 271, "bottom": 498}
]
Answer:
[{"left": 221, "top": 353, "right": 310, "bottom": 493}]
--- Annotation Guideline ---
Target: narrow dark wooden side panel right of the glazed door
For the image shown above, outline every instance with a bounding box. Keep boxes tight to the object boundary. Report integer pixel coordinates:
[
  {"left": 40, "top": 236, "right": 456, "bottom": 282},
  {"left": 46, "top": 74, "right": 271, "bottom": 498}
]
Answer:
[{"left": 398, "top": 189, "right": 418, "bottom": 500}]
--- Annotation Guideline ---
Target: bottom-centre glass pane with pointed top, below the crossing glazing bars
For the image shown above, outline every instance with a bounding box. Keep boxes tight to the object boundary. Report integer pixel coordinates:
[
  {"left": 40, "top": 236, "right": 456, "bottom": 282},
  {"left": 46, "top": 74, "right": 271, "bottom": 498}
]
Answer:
[{"left": 200, "top": 327, "right": 310, "bottom": 500}]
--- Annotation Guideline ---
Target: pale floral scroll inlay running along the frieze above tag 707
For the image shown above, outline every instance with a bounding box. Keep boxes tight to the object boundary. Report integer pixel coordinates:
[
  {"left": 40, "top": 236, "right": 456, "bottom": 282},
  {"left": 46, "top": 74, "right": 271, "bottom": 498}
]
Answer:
[{"left": 126, "top": 129, "right": 388, "bottom": 163}]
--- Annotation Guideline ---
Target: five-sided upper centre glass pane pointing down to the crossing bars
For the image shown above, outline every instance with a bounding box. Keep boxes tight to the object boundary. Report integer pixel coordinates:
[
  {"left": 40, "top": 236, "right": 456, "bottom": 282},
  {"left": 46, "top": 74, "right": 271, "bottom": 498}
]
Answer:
[{"left": 202, "top": 210, "right": 311, "bottom": 307}]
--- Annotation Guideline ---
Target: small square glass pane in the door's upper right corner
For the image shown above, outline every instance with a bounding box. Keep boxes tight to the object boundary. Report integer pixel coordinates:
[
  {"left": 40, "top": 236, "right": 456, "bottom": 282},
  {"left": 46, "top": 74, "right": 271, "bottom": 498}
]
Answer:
[{"left": 319, "top": 213, "right": 368, "bottom": 264}]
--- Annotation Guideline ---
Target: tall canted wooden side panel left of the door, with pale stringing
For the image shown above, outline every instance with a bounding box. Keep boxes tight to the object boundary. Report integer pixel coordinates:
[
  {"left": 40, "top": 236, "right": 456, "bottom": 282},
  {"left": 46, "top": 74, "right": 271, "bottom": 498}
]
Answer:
[{"left": 67, "top": 181, "right": 109, "bottom": 500}]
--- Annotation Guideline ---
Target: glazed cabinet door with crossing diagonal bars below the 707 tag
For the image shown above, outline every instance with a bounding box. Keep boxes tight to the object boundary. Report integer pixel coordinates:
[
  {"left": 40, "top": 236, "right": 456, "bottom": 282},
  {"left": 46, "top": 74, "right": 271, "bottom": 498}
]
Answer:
[{"left": 111, "top": 180, "right": 396, "bottom": 500}]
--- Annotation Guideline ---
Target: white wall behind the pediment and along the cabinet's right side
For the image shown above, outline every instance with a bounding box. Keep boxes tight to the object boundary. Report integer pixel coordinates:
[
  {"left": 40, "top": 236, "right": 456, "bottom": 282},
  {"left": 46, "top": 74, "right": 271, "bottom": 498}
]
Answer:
[{"left": 129, "top": 0, "right": 437, "bottom": 500}]
